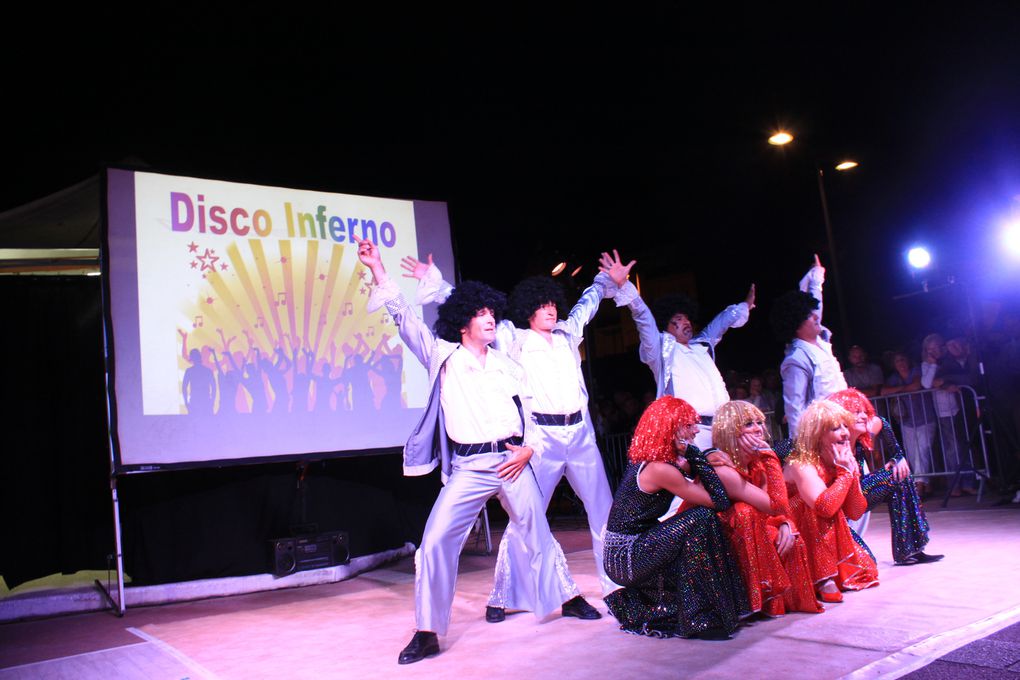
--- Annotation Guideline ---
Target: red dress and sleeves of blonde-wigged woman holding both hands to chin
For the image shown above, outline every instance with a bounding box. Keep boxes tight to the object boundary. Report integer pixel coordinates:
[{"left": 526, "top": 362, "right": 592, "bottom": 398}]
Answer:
[{"left": 788, "top": 464, "right": 878, "bottom": 590}]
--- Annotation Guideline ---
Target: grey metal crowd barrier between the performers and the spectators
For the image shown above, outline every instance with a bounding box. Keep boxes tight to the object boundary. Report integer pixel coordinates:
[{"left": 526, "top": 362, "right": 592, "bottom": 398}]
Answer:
[{"left": 599, "top": 385, "right": 990, "bottom": 505}]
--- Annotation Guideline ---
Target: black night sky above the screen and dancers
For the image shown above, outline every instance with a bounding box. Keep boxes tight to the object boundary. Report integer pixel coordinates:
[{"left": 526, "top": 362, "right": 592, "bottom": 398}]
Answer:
[{"left": 0, "top": 2, "right": 1020, "bottom": 367}]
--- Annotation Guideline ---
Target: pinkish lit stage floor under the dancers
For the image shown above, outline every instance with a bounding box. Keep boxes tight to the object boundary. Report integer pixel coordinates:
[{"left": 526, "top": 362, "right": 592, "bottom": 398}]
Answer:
[{"left": 0, "top": 499, "right": 1020, "bottom": 680}]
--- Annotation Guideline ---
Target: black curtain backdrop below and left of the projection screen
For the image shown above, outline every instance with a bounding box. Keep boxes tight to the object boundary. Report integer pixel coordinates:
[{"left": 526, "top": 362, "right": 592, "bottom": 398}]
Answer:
[{"left": 0, "top": 276, "right": 440, "bottom": 587}]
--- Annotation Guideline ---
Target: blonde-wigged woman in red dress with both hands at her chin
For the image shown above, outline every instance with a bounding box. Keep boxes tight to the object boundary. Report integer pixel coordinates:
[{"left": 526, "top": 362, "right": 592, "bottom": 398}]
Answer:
[{"left": 784, "top": 400, "right": 878, "bottom": 603}]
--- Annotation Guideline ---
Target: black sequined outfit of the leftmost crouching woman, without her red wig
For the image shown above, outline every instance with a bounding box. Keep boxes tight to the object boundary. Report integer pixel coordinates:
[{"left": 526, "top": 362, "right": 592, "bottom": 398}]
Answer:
[{"left": 605, "top": 448, "right": 750, "bottom": 637}]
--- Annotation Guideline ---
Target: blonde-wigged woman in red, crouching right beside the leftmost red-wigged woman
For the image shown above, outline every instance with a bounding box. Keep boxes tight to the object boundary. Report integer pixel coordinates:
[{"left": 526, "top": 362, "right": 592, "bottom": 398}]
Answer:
[{"left": 712, "top": 402, "right": 823, "bottom": 617}]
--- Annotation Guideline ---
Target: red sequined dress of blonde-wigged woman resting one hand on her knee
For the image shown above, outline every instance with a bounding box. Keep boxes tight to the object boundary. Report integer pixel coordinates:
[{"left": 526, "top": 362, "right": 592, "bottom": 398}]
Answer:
[{"left": 719, "top": 451, "right": 824, "bottom": 616}]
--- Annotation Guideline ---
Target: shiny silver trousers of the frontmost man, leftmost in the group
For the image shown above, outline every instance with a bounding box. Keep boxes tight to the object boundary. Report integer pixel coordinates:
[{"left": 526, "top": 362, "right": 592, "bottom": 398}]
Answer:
[{"left": 414, "top": 453, "right": 576, "bottom": 635}]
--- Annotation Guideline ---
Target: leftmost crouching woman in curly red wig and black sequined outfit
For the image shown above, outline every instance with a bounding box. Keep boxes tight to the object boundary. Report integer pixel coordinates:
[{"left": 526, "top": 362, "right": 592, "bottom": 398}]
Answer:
[{"left": 604, "top": 397, "right": 749, "bottom": 639}]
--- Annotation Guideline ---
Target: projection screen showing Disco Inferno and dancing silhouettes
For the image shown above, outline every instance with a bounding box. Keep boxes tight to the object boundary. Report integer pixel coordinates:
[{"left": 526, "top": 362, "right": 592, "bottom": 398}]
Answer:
[{"left": 103, "top": 169, "right": 454, "bottom": 472}]
